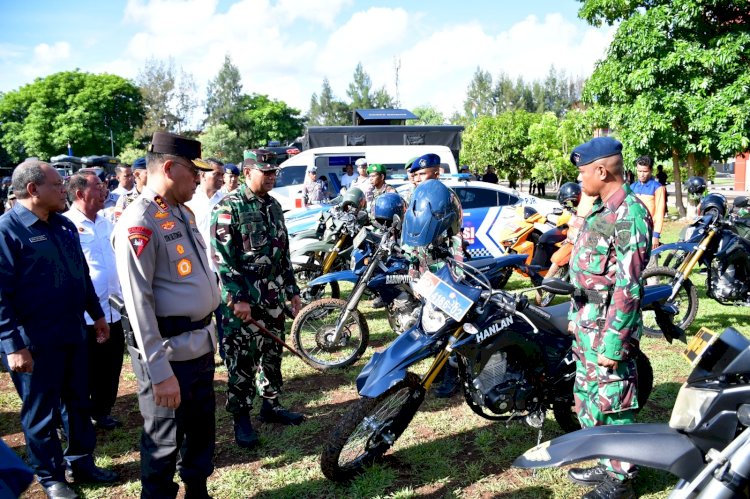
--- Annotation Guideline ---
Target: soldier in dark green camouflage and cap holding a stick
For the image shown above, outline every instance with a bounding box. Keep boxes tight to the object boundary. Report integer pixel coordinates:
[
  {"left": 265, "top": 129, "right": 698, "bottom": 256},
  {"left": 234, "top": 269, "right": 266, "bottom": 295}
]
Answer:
[{"left": 211, "top": 158, "right": 304, "bottom": 448}]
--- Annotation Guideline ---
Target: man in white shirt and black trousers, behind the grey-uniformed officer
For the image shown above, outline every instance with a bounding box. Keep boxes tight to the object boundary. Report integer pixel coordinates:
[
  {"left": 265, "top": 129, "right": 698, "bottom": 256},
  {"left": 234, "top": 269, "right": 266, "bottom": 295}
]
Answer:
[{"left": 63, "top": 171, "right": 125, "bottom": 430}]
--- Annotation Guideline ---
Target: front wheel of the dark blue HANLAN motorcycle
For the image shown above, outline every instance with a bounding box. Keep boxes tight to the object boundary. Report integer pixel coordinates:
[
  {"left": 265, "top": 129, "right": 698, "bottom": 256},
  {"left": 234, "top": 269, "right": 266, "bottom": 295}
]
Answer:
[{"left": 320, "top": 373, "right": 424, "bottom": 482}]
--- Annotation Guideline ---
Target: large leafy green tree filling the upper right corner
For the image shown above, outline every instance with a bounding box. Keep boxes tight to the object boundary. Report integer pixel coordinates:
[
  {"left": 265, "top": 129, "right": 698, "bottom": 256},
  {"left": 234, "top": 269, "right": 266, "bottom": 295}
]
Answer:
[{"left": 579, "top": 0, "right": 750, "bottom": 215}]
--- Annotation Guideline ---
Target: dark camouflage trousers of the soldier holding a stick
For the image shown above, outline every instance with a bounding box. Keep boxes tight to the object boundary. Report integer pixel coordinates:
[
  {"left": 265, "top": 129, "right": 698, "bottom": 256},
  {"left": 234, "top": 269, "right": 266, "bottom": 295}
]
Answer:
[{"left": 223, "top": 307, "right": 284, "bottom": 414}]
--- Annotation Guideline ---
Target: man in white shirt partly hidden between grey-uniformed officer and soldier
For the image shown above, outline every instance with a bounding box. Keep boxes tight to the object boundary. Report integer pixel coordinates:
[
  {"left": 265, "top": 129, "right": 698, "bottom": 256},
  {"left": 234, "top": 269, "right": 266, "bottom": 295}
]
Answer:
[{"left": 185, "top": 158, "right": 226, "bottom": 359}]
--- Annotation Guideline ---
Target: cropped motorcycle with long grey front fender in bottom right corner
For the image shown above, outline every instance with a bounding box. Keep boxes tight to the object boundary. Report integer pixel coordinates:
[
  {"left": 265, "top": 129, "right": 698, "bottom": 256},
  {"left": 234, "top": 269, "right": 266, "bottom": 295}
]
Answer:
[{"left": 513, "top": 327, "right": 750, "bottom": 499}]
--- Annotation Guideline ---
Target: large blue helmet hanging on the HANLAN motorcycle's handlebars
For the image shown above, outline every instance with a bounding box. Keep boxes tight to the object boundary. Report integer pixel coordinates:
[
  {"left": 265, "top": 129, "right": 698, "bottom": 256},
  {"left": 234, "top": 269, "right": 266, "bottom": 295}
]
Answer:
[{"left": 401, "top": 179, "right": 463, "bottom": 247}]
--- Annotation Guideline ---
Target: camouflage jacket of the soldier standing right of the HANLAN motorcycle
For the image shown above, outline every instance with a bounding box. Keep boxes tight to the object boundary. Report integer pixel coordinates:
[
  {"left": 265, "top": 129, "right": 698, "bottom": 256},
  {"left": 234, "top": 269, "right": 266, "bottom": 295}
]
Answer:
[{"left": 568, "top": 185, "right": 653, "bottom": 361}]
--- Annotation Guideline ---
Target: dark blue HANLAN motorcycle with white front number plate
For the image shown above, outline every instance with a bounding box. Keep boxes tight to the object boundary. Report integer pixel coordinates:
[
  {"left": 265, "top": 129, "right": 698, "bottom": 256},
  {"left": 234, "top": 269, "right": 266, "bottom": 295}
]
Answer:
[{"left": 321, "top": 191, "right": 681, "bottom": 481}]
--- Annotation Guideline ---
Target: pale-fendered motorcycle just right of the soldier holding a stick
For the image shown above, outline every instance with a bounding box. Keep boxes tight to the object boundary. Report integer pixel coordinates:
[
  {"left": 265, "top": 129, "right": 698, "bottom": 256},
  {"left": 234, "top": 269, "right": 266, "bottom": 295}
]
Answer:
[{"left": 289, "top": 188, "right": 368, "bottom": 304}]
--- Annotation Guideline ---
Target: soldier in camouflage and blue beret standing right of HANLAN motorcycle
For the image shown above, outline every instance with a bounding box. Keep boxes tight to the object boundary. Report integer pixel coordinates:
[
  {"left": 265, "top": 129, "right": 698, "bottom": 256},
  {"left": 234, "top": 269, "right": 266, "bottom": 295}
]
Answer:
[{"left": 568, "top": 137, "right": 653, "bottom": 499}]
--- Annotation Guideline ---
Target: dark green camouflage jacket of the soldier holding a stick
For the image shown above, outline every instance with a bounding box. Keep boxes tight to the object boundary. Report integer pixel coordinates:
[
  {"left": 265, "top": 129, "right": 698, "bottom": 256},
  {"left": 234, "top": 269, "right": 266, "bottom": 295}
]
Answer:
[{"left": 211, "top": 185, "right": 299, "bottom": 327}]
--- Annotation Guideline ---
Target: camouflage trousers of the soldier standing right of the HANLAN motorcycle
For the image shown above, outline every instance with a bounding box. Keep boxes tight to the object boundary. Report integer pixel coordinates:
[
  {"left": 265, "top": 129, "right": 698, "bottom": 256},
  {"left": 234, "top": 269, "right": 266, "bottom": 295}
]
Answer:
[{"left": 573, "top": 327, "right": 638, "bottom": 480}]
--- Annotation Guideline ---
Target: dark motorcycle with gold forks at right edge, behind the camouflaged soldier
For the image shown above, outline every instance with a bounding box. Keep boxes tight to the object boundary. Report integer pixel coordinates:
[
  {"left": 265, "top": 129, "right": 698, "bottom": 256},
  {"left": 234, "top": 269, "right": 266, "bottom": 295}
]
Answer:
[{"left": 643, "top": 193, "right": 750, "bottom": 336}]
